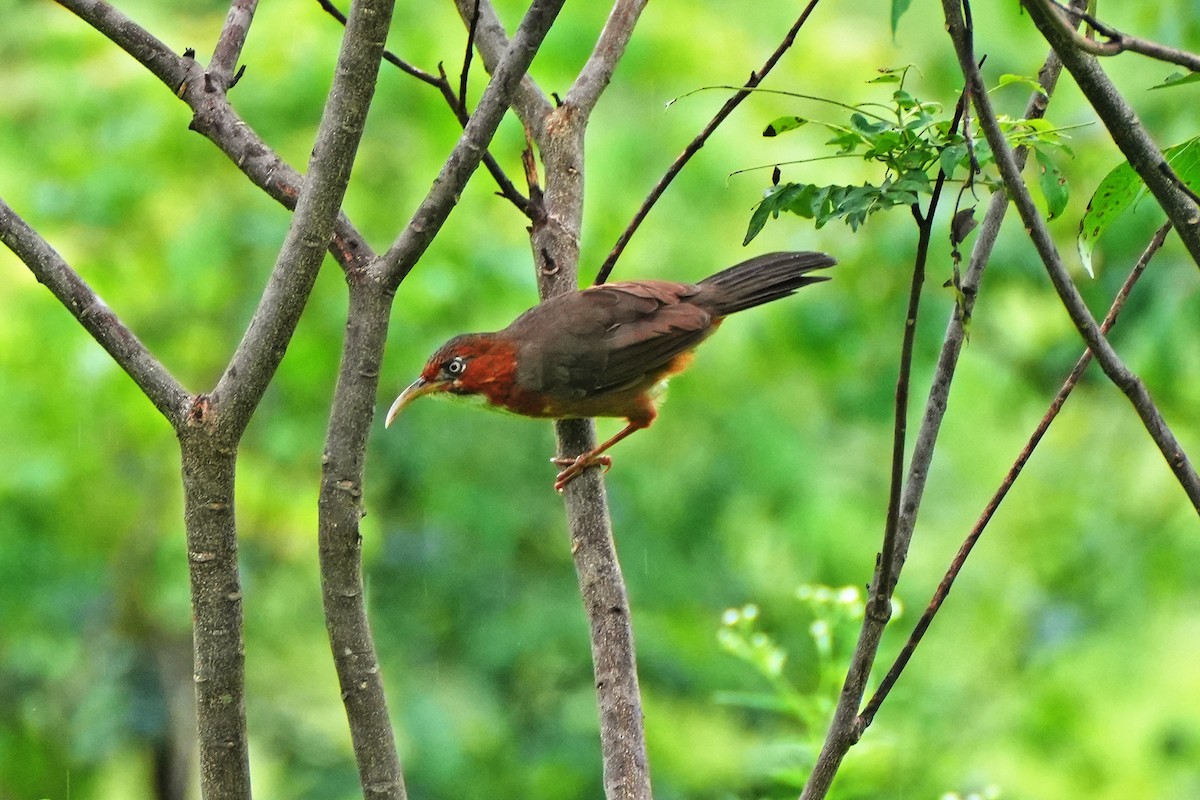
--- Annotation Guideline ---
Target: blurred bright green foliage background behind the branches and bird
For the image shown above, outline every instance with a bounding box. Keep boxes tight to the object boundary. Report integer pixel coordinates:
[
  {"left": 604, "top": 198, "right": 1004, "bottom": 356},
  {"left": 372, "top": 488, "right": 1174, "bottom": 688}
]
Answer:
[{"left": 0, "top": 0, "right": 1200, "bottom": 800}]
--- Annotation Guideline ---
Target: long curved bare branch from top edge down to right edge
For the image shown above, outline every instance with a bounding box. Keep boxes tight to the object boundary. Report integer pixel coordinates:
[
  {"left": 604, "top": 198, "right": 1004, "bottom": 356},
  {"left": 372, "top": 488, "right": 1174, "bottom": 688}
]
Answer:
[{"left": 942, "top": 0, "right": 1200, "bottom": 513}]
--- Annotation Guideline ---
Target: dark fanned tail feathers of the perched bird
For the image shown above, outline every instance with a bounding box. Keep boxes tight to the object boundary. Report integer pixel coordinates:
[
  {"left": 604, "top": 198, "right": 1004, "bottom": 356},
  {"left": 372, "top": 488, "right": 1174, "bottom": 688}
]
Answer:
[{"left": 692, "top": 252, "right": 838, "bottom": 317}]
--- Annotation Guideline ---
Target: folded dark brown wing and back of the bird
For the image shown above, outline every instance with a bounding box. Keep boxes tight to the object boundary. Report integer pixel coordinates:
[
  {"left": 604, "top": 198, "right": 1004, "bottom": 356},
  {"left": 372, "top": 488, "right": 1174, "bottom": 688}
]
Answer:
[{"left": 506, "top": 281, "right": 713, "bottom": 399}]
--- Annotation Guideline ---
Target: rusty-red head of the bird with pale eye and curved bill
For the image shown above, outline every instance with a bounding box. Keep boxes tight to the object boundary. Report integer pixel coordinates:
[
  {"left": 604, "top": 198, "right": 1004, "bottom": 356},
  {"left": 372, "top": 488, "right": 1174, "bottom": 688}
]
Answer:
[{"left": 384, "top": 333, "right": 516, "bottom": 427}]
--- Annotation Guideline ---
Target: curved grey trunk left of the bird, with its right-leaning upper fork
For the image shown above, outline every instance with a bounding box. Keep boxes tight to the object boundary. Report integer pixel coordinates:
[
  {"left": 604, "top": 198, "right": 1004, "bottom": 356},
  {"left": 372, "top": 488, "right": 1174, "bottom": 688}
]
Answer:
[{"left": 318, "top": 0, "right": 562, "bottom": 800}]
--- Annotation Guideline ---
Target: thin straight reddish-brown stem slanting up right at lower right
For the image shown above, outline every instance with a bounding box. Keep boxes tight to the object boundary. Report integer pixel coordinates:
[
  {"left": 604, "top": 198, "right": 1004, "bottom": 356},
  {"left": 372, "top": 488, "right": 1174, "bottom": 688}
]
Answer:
[{"left": 860, "top": 223, "right": 1171, "bottom": 726}]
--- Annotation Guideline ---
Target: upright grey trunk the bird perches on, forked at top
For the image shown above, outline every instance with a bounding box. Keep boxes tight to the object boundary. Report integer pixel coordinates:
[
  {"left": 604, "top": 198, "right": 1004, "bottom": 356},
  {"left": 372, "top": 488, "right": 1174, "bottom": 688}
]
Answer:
[{"left": 456, "top": 0, "right": 650, "bottom": 800}]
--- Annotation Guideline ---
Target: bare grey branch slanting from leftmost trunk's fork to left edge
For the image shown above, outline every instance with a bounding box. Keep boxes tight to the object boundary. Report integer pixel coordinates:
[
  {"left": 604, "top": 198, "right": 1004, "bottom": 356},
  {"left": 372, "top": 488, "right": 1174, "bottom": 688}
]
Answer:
[{"left": 0, "top": 199, "right": 190, "bottom": 428}]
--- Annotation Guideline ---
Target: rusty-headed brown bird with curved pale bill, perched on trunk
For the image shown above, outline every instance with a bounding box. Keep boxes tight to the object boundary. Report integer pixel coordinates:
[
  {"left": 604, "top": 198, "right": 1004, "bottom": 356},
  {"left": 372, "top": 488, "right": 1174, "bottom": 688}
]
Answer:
[{"left": 384, "top": 252, "right": 836, "bottom": 493}]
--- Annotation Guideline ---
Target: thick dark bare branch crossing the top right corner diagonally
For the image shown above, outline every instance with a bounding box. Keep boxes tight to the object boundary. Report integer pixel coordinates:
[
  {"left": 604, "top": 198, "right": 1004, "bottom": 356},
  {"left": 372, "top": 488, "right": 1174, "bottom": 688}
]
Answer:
[{"left": 1021, "top": 0, "right": 1200, "bottom": 268}]
